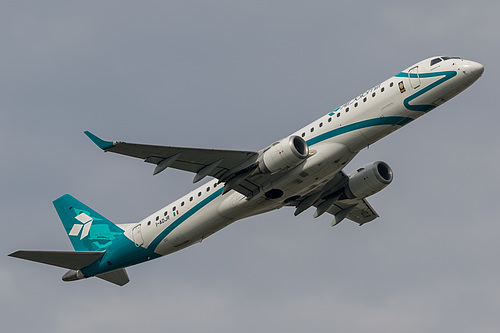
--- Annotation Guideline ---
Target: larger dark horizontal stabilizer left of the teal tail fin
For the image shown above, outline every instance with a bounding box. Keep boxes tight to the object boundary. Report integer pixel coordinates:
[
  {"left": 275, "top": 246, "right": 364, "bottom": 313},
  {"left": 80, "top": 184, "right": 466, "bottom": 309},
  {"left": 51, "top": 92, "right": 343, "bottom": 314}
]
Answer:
[{"left": 9, "top": 250, "right": 106, "bottom": 270}]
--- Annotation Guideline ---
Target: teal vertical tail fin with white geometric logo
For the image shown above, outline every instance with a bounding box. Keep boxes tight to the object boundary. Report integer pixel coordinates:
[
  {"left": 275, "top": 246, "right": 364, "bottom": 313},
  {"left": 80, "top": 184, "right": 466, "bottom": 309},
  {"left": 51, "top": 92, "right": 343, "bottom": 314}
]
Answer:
[{"left": 54, "top": 194, "right": 123, "bottom": 251}]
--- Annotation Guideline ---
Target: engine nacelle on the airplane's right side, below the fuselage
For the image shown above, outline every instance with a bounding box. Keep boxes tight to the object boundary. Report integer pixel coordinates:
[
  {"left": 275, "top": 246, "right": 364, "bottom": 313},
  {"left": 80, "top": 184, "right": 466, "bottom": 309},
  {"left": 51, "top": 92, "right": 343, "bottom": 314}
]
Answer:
[{"left": 345, "top": 162, "right": 393, "bottom": 199}]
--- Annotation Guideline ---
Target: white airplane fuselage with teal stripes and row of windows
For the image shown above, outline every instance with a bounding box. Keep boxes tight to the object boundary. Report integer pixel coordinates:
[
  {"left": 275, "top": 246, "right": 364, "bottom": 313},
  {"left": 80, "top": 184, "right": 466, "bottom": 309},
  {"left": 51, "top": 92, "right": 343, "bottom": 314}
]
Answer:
[{"left": 125, "top": 58, "right": 482, "bottom": 255}]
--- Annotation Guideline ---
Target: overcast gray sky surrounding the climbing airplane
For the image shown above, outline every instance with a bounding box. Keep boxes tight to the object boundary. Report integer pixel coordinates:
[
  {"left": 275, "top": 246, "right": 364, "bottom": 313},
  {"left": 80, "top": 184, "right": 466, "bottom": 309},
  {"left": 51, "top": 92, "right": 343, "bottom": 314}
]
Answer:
[{"left": 0, "top": 0, "right": 500, "bottom": 333}]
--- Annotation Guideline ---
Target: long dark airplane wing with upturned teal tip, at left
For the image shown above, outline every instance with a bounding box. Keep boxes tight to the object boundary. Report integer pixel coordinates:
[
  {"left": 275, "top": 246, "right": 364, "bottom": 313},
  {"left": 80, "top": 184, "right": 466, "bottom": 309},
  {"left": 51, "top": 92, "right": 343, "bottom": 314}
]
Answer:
[{"left": 85, "top": 131, "right": 262, "bottom": 197}]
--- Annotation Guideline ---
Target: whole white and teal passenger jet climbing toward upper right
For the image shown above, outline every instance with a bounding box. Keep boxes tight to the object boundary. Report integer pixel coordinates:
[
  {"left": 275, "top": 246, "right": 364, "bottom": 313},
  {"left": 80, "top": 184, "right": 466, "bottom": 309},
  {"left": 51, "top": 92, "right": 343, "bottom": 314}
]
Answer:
[{"left": 9, "top": 56, "right": 484, "bottom": 286}]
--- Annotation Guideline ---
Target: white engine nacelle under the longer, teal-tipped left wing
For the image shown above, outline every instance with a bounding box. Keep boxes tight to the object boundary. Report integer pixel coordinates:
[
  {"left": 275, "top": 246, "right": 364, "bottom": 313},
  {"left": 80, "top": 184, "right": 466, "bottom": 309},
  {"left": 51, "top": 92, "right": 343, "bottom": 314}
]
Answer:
[{"left": 259, "top": 135, "right": 309, "bottom": 173}]
